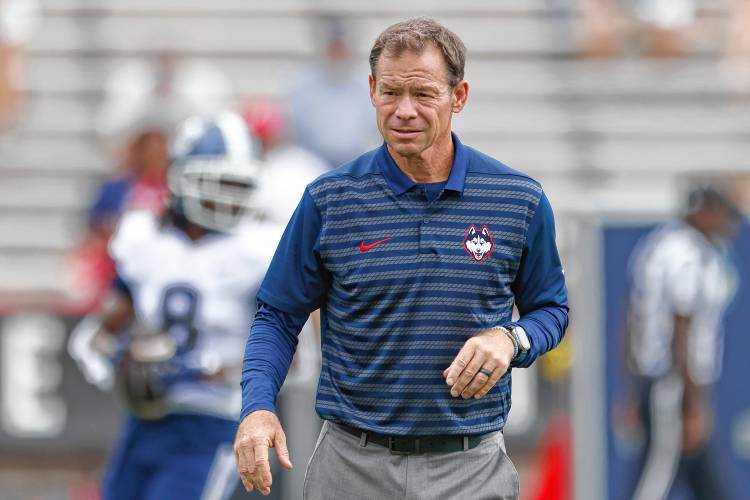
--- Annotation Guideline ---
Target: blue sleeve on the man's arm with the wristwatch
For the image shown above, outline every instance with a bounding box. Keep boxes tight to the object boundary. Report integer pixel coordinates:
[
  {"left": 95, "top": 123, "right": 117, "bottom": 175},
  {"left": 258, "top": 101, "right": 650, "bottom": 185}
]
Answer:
[{"left": 509, "top": 193, "right": 568, "bottom": 367}]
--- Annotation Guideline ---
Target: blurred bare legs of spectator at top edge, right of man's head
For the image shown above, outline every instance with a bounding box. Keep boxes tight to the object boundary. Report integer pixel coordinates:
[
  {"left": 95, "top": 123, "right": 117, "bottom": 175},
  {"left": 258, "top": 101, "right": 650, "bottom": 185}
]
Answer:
[{"left": 581, "top": 0, "right": 697, "bottom": 57}]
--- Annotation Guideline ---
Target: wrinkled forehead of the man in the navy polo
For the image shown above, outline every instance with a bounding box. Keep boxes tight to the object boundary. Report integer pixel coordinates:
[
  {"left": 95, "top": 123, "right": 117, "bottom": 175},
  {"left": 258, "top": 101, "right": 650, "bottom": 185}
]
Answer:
[{"left": 375, "top": 44, "right": 448, "bottom": 85}]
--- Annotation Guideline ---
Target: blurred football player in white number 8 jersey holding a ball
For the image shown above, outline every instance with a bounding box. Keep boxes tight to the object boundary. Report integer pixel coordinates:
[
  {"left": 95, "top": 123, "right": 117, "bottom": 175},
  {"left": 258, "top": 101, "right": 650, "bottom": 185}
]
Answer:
[{"left": 69, "top": 113, "right": 280, "bottom": 500}]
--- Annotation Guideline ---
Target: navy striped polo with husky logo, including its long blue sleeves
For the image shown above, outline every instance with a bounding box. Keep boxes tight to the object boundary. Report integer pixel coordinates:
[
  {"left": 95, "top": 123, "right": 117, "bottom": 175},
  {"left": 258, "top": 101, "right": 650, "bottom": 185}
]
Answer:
[{"left": 242, "top": 135, "right": 568, "bottom": 435}]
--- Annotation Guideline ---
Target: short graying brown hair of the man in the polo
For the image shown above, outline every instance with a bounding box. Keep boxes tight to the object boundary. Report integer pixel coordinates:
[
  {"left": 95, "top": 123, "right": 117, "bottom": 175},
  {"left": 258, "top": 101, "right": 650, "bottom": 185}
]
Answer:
[{"left": 370, "top": 17, "right": 466, "bottom": 87}]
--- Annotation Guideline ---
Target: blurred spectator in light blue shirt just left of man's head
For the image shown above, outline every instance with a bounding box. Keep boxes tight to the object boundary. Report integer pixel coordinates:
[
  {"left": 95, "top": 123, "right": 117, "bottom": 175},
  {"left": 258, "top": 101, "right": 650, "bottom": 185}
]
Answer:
[{"left": 287, "top": 17, "right": 379, "bottom": 168}]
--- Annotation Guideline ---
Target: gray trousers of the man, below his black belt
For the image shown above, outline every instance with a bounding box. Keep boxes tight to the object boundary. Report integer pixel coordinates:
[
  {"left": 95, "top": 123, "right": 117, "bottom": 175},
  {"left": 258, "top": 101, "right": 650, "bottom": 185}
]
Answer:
[{"left": 303, "top": 422, "right": 519, "bottom": 500}]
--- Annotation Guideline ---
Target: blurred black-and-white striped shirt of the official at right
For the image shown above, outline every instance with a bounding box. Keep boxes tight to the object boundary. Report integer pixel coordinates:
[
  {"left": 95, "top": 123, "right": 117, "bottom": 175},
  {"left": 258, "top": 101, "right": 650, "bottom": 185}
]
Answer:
[{"left": 630, "top": 222, "right": 737, "bottom": 384}]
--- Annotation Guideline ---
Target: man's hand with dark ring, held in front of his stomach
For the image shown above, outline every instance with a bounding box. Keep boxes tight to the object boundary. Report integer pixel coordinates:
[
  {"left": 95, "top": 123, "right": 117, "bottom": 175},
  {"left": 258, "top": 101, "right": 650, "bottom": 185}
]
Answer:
[{"left": 443, "top": 328, "right": 515, "bottom": 399}]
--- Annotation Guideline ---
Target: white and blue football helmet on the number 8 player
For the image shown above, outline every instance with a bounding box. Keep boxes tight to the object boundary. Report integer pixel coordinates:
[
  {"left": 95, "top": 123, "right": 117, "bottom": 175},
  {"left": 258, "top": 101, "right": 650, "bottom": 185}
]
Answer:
[{"left": 167, "top": 112, "right": 261, "bottom": 231}]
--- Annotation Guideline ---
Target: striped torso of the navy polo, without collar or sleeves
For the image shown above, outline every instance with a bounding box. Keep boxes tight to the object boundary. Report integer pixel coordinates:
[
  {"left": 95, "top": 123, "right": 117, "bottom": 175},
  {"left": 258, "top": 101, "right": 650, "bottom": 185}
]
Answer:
[{"left": 308, "top": 154, "right": 541, "bottom": 435}]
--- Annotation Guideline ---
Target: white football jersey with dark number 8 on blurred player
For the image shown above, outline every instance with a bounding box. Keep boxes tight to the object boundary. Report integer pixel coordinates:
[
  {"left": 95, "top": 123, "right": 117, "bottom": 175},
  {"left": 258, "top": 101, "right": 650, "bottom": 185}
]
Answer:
[{"left": 110, "top": 211, "right": 283, "bottom": 419}]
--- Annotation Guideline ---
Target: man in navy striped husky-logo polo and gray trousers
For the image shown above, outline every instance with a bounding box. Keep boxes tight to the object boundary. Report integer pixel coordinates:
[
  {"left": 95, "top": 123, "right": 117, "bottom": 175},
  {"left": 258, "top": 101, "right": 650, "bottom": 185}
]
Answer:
[{"left": 235, "top": 18, "right": 568, "bottom": 499}]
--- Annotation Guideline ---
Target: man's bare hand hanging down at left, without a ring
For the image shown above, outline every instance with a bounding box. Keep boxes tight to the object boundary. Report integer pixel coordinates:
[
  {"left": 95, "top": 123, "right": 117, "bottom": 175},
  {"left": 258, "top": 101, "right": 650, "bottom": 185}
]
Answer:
[{"left": 234, "top": 410, "right": 292, "bottom": 495}]
